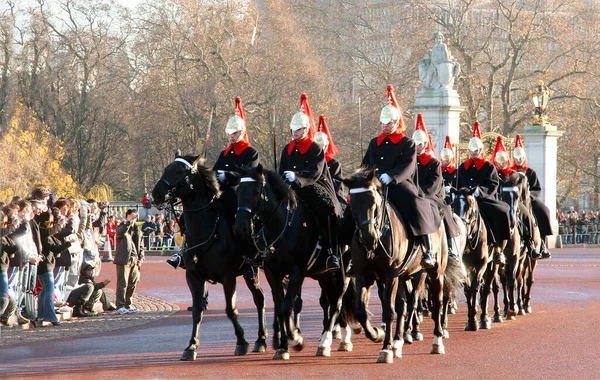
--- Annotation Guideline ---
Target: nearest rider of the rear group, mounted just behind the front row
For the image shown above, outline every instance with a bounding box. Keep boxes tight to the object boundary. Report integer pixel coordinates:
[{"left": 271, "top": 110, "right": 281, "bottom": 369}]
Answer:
[{"left": 457, "top": 122, "right": 510, "bottom": 263}]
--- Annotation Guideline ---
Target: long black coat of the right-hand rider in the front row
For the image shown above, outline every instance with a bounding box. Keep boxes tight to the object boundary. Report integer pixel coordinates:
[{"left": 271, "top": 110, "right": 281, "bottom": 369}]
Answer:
[{"left": 362, "top": 136, "right": 441, "bottom": 236}]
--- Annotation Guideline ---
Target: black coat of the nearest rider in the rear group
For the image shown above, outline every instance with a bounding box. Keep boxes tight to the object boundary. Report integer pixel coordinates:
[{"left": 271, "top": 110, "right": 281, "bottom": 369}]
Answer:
[{"left": 457, "top": 161, "right": 510, "bottom": 243}]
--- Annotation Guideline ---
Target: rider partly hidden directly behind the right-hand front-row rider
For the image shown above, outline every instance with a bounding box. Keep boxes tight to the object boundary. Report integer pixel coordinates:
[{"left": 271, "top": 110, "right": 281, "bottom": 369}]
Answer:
[{"left": 413, "top": 114, "right": 460, "bottom": 260}]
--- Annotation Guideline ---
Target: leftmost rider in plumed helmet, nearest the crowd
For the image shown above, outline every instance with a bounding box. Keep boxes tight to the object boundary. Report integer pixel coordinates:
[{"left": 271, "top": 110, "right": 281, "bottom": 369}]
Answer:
[{"left": 167, "top": 98, "right": 258, "bottom": 274}]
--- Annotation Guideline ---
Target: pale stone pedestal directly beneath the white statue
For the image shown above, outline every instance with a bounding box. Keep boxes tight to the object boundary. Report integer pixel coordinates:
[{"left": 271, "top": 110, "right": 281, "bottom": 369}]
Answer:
[{"left": 413, "top": 88, "right": 465, "bottom": 152}]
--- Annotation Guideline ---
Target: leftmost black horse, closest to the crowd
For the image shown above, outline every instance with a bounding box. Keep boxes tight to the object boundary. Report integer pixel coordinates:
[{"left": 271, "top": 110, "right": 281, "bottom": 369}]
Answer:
[{"left": 152, "top": 152, "right": 267, "bottom": 360}]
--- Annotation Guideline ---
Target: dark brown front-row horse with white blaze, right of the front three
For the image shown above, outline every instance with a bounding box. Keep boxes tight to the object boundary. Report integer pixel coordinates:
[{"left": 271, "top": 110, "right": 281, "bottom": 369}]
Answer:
[{"left": 343, "top": 169, "right": 448, "bottom": 363}]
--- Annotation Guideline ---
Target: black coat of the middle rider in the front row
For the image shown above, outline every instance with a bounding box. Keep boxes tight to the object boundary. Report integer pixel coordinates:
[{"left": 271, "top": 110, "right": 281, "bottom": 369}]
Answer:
[{"left": 279, "top": 142, "right": 342, "bottom": 220}]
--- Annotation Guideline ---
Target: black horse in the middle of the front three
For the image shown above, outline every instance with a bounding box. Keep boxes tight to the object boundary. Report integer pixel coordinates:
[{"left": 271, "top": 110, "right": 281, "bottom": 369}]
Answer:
[{"left": 234, "top": 164, "right": 352, "bottom": 360}]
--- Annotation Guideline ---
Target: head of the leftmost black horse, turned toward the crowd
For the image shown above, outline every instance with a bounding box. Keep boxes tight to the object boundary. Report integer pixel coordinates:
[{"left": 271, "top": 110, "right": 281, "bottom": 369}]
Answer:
[{"left": 152, "top": 152, "right": 212, "bottom": 207}]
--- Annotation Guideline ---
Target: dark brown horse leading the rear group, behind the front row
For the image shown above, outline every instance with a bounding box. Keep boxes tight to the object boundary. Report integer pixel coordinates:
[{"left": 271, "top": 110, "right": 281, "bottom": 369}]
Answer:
[{"left": 452, "top": 188, "right": 493, "bottom": 331}]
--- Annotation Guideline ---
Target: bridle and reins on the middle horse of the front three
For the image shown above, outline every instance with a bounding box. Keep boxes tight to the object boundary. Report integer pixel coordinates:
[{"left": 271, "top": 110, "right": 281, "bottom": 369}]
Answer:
[{"left": 237, "top": 177, "right": 296, "bottom": 257}]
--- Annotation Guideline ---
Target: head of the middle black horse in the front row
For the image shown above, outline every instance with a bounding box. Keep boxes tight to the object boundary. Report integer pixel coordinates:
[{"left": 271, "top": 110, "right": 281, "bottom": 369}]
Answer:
[{"left": 233, "top": 164, "right": 296, "bottom": 239}]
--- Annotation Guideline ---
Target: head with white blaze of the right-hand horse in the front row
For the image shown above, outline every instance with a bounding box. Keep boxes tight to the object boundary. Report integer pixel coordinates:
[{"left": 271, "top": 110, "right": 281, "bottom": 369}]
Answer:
[{"left": 343, "top": 169, "right": 382, "bottom": 251}]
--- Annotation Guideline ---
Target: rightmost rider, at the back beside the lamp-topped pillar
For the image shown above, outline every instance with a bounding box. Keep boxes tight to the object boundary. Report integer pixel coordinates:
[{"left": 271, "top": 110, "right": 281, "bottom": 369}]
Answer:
[{"left": 513, "top": 135, "right": 554, "bottom": 259}]
